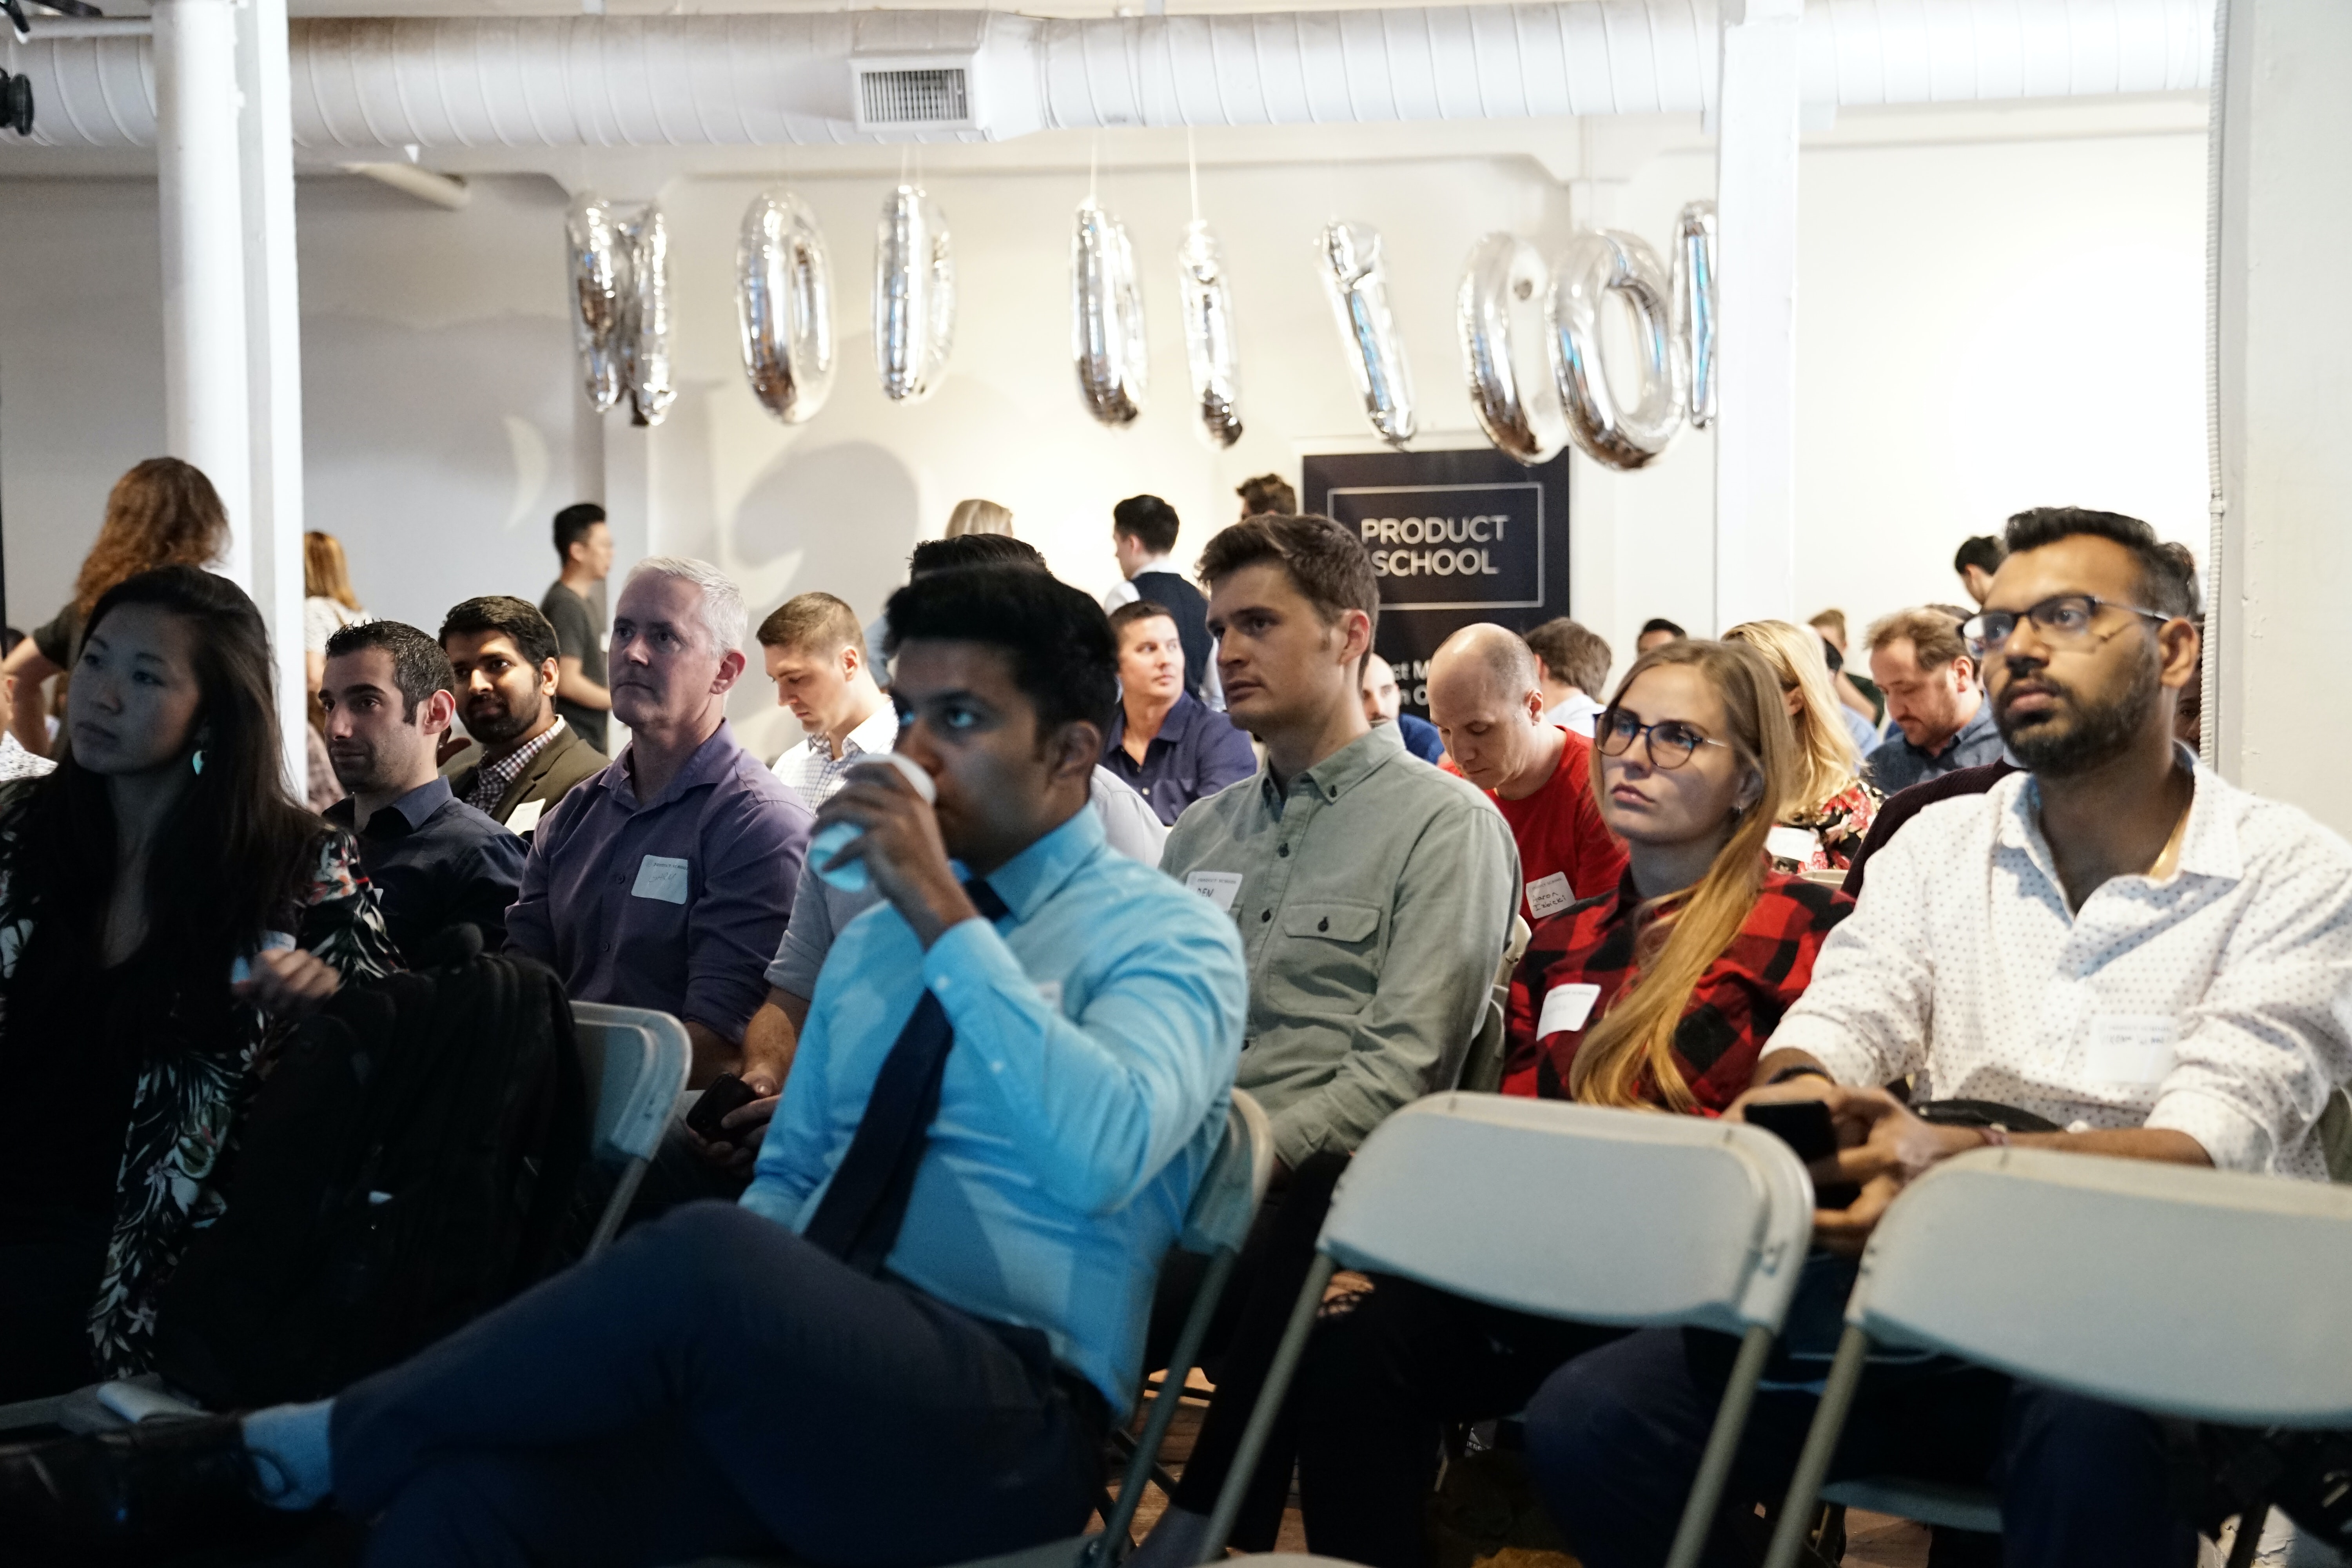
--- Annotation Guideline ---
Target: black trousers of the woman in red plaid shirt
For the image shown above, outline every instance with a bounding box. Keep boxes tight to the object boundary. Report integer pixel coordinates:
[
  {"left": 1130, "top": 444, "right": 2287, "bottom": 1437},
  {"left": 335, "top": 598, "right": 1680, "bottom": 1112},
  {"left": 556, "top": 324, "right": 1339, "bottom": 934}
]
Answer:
[{"left": 1291, "top": 1274, "right": 1623, "bottom": 1568}]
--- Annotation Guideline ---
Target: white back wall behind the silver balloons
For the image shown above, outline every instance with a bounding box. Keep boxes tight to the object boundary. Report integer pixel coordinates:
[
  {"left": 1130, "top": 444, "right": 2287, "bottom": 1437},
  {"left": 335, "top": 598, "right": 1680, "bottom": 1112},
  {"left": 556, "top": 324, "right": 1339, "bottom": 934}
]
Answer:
[{"left": 0, "top": 111, "right": 2204, "bottom": 750}]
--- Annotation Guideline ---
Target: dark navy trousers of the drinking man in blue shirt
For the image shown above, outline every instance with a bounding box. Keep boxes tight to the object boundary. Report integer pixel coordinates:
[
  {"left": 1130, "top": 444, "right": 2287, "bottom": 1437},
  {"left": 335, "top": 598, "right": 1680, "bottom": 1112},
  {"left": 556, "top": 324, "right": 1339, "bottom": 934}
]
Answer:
[{"left": 332, "top": 1203, "right": 1103, "bottom": 1568}]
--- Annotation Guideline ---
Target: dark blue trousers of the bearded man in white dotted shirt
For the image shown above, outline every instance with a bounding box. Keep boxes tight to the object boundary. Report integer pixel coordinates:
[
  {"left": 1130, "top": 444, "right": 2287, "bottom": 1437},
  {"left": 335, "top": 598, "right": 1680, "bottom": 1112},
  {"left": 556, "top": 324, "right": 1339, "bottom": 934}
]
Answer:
[{"left": 1524, "top": 1328, "right": 2197, "bottom": 1568}]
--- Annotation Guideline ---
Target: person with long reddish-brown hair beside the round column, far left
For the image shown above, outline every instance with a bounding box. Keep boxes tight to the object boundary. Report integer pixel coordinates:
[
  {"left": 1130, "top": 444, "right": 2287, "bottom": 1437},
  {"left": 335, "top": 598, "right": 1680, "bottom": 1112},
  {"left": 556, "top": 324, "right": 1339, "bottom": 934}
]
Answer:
[{"left": 0, "top": 458, "right": 228, "bottom": 757}]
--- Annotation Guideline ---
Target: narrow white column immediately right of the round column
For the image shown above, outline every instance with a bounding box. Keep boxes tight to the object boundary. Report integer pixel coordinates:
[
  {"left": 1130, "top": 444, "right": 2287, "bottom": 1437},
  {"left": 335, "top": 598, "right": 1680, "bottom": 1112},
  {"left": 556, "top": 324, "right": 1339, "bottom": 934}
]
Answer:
[{"left": 235, "top": 0, "right": 308, "bottom": 795}]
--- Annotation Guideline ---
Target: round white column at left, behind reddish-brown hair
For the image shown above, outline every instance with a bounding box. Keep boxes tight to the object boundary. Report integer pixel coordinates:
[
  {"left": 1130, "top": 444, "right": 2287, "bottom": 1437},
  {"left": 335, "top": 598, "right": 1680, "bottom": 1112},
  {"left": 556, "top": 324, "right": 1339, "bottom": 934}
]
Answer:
[{"left": 155, "top": 0, "right": 252, "bottom": 564}]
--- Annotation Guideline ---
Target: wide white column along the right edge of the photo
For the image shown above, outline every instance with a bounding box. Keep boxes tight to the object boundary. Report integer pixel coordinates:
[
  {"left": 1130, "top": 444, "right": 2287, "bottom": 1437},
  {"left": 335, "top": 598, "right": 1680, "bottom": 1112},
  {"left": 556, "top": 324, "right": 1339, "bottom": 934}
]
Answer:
[{"left": 2206, "top": 0, "right": 2352, "bottom": 835}]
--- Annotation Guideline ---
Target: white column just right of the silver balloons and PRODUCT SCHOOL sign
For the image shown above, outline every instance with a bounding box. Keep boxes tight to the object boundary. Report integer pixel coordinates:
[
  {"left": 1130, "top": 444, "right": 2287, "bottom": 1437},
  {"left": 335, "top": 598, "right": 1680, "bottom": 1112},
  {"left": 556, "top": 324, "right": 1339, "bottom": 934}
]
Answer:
[{"left": 1715, "top": 0, "right": 1804, "bottom": 632}]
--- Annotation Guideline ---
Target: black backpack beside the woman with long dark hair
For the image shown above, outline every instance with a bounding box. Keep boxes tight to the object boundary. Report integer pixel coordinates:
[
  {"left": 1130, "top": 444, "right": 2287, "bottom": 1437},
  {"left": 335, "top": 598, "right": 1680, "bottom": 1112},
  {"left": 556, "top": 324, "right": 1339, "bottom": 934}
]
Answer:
[{"left": 155, "top": 957, "right": 588, "bottom": 1410}]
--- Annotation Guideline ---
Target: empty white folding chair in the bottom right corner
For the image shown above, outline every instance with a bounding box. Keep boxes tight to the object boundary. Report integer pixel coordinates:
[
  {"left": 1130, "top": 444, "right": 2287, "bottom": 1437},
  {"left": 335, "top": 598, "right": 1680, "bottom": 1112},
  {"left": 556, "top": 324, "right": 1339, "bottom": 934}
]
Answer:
[{"left": 1766, "top": 1150, "right": 2352, "bottom": 1568}]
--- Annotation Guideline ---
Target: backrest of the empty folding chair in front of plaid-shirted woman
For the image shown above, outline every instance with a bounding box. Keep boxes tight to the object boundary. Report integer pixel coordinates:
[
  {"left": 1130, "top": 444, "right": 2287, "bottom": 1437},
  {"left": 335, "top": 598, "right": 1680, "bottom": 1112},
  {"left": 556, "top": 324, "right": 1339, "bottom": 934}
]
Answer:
[{"left": 1322, "top": 1093, "right": 1813, "bottom": 1333}]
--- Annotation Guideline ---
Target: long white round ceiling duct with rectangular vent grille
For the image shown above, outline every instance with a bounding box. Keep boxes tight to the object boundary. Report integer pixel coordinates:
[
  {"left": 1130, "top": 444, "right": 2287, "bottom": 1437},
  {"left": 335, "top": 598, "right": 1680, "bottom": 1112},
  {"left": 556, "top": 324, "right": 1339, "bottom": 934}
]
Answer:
[{"left": 7, "top": 0, "right": 2213, "bottom": 158}]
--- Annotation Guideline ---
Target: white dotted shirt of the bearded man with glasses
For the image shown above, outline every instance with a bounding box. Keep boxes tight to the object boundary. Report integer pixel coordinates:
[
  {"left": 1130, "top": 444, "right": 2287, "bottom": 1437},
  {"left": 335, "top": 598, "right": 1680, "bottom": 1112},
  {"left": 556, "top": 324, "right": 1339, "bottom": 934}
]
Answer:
[{"left": 1771, "top": 750, "right": 2352, "bottom": 1180}]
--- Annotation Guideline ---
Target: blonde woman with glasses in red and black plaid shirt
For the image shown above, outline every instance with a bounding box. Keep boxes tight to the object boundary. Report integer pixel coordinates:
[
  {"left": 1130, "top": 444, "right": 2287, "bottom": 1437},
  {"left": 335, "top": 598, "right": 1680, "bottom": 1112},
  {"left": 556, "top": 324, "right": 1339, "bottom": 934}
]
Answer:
[{"left": 1275, "top": 639, "right": 1849, "bottom": 1568}]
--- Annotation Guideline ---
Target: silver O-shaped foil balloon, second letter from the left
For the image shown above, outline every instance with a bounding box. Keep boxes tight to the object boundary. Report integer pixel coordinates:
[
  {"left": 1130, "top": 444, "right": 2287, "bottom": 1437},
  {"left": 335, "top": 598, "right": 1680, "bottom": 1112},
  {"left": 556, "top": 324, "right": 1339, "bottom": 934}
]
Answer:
[{"left": 736, "top": 191, "right": 833, "bottom": 425}]
